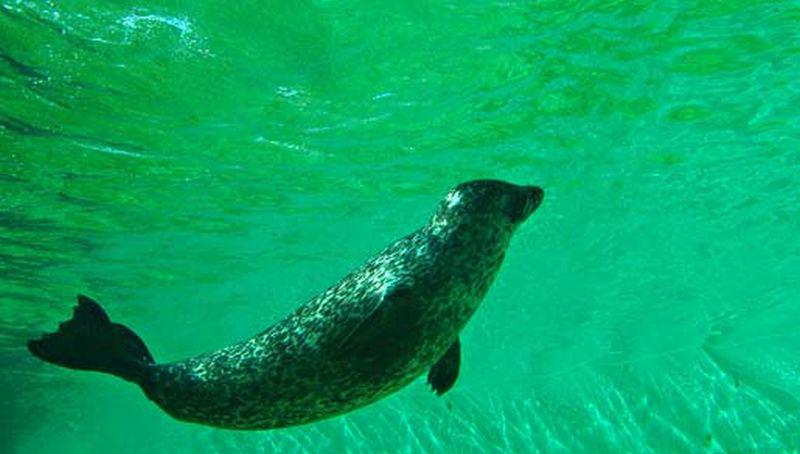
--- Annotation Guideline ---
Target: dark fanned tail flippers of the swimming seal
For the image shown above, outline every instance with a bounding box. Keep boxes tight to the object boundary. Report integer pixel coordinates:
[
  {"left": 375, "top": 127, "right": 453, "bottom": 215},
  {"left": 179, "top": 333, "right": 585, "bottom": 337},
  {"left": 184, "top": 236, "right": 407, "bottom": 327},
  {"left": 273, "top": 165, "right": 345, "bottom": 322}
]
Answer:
[{"left": 28, "top": 295, "right": 154, "bottom": 384}]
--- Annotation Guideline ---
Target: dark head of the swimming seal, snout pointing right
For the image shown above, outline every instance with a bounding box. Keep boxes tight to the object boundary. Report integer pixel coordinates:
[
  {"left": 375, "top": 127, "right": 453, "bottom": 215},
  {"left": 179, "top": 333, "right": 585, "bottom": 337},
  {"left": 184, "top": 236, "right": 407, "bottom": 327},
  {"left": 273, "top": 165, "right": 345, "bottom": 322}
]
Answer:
[{"left": 434, "top": 180, "right": 544, "bottom": 229}]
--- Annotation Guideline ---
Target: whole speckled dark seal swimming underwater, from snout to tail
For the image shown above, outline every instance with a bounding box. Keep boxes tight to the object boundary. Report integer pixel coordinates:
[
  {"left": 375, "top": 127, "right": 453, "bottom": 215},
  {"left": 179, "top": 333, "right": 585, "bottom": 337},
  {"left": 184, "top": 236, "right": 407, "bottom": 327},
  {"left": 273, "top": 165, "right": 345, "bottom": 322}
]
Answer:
[{"left": 28, "top": 180, "right": 544, "bottom": 429}]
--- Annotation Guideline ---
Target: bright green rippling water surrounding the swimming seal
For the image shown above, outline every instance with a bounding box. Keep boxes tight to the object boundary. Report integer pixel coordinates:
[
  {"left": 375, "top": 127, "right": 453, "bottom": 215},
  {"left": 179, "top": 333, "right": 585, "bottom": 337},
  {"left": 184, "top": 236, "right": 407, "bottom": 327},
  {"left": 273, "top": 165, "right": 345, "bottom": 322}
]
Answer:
[{"left": 0, "top": 0, "right": 800, "bottom": 453}]
